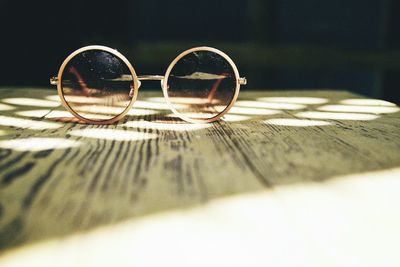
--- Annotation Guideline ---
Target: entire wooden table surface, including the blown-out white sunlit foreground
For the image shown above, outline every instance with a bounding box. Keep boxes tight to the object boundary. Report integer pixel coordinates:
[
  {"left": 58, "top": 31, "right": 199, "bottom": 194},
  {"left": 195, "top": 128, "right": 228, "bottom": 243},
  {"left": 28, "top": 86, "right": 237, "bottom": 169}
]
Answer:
[{"left": 0, "top": 88, "right": 400, "bottom": 266}]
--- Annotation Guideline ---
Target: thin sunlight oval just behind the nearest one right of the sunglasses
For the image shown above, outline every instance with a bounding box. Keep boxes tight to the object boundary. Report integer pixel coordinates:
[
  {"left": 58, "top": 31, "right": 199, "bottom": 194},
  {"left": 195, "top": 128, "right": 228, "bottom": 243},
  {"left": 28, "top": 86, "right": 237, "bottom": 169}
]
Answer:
[{"left": 296, "top": 111, "right": 380, "bottom": 121}]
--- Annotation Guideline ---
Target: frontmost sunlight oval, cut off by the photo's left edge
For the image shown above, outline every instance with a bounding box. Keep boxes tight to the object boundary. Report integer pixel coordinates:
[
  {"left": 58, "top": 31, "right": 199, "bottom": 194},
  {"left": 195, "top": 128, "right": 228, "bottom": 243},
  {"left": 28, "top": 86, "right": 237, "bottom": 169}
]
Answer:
[{"left": 0, "top": 137, "right": 81, "bottom": 151}]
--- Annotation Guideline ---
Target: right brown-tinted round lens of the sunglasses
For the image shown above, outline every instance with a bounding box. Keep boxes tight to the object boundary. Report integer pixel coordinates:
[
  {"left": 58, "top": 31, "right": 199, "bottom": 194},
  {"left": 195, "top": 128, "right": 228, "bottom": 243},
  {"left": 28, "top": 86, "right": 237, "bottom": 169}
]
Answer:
[{"left": 167, "top": 51, "right": 237, "bottom": 120}]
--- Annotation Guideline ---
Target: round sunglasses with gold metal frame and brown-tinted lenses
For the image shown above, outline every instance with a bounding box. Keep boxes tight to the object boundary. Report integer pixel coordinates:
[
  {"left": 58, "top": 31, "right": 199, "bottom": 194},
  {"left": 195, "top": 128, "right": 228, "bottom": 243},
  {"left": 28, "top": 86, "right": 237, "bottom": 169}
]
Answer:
[{"left": 50, "top": 45, "right": 247, "bottom": 124}]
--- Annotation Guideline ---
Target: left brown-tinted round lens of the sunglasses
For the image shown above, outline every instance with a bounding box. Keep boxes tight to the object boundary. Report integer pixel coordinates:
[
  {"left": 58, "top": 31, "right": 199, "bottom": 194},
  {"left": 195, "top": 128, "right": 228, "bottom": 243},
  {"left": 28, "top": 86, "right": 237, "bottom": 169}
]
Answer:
[{"left": 61, "top": 50, "right": 134, "bottom": 121}]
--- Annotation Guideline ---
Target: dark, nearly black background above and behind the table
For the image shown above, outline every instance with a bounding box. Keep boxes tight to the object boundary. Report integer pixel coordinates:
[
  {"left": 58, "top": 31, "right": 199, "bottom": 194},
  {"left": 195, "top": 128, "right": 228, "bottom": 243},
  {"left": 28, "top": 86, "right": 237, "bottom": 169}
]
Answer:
[{"left": 0, "top": 0, "right": 400, "bottom": 103}]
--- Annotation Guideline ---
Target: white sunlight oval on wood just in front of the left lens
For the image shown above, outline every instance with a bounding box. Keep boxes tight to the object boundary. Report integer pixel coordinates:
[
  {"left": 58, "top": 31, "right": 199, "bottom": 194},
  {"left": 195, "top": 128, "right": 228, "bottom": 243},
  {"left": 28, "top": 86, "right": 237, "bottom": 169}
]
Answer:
[{"left": 69, "top": 128, "right": 158, "bottom": 141}]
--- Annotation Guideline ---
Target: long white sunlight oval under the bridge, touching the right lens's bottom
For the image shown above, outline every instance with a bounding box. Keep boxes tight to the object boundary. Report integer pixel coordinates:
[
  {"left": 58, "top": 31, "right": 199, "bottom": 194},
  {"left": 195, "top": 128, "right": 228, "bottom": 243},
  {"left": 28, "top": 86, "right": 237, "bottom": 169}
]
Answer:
[{"left": 120, "top": 121, "right": 212, "bottom": 131}]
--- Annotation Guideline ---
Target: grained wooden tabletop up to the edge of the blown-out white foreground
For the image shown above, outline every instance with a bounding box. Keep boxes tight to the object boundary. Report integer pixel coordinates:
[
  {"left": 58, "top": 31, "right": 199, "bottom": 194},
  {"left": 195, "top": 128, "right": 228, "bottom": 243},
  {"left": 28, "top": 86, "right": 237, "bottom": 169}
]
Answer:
[{"left": 0, "top": 88, "right": 400, "bottom": 255}]
